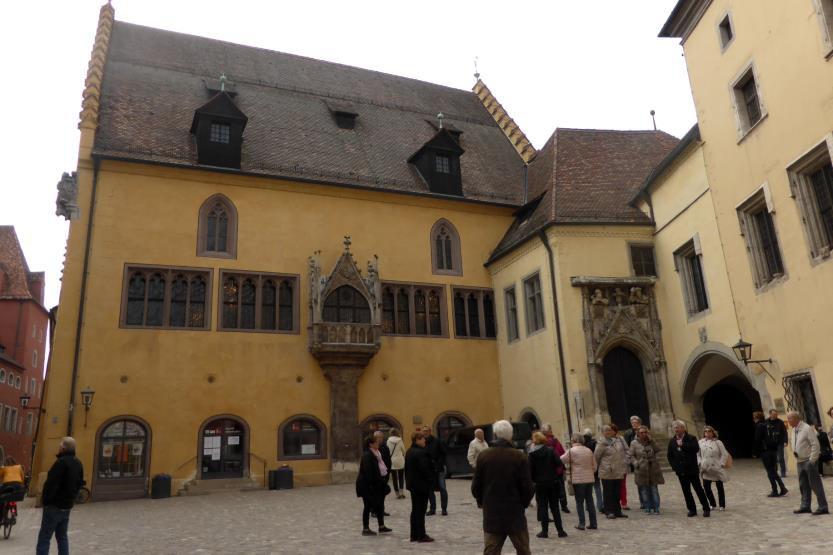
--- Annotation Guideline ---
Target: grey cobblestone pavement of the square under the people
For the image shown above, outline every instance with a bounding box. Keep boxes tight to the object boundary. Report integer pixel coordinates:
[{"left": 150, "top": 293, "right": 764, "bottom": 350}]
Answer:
[{"left": 6, "top": 461, "right": 833, "bottom": 555}]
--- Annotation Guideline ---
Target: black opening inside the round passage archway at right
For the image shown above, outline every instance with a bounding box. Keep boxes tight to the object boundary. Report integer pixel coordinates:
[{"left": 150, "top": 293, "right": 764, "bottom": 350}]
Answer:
[{"left": 703, "top": 376, "right": 762, "bottom": 458}]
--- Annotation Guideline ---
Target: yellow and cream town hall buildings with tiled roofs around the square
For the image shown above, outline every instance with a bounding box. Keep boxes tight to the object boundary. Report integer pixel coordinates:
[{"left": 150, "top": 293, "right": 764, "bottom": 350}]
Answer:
[{"left": 35, "top": 0, "right": 833, "bottom": 499}]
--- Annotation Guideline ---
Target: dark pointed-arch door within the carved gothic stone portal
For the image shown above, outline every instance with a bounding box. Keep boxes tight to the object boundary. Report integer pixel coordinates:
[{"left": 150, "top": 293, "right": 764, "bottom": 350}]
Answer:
[{"left": 602, "top": 347, "right": 651, "bottom": 430}]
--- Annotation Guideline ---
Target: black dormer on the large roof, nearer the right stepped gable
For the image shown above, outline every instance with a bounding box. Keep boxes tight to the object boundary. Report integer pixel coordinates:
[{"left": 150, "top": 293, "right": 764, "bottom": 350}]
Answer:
[{"left": 408, "top": 127, "right": 466, "bottom": 196}]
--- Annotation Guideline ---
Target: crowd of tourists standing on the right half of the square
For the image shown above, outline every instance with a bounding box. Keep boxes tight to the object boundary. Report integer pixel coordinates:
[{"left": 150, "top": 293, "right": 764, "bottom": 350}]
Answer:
[{"left": 356, "top": 408, "right": 833, "bottom": 554}]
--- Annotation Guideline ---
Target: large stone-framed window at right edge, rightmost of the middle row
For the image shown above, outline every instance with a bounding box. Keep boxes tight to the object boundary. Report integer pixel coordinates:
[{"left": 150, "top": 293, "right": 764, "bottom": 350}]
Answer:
[{"left": 787, "top": 141, "right": 833, "bottom": 259}]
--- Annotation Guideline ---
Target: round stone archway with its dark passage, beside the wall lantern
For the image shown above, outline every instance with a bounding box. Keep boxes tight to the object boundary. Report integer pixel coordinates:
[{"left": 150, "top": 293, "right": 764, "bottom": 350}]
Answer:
[{"left": 682, "top": 342, "right": 772, "bottom": 458}]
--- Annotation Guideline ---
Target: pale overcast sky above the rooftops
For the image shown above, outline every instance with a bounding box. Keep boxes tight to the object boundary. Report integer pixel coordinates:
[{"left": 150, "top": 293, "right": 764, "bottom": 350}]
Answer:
[{"left": 0, "top": 0, "right": 695, "bottom": 307}]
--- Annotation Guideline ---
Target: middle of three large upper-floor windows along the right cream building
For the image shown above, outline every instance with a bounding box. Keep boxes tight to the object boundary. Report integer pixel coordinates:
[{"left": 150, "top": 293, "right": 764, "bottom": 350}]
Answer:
[{"left": 737, "top": 186, "right": 784, "bottom": 288}]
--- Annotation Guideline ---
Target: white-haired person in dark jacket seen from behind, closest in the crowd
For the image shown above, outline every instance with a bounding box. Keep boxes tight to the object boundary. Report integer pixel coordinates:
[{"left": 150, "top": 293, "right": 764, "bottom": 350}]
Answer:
[{"left": 471, "top": 420, "right": 534, "bottom": 553}]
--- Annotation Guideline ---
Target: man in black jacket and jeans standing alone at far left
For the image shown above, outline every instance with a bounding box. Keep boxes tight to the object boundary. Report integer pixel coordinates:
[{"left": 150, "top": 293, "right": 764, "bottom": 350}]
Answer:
[{"left": 36, "top": 437, "right": 84, "bottom": 555}]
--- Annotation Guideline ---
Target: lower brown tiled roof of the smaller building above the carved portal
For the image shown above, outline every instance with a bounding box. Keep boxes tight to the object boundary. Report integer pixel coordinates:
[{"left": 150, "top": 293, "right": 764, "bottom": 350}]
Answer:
[{"left": 490, "top": 128, "right": 679, "bottom": 261}]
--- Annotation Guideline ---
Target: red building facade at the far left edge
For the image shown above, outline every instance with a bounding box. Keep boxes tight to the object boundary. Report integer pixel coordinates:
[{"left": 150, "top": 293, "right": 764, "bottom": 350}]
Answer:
[{"left": 0, "top": 226, "right": 49, "bottom": 470}]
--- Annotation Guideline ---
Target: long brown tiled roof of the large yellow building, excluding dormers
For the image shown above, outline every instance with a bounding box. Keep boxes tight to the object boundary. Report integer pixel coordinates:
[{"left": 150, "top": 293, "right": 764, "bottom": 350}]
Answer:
[{"left": 94, "top": 21, "right": 523, "bottom": 206}]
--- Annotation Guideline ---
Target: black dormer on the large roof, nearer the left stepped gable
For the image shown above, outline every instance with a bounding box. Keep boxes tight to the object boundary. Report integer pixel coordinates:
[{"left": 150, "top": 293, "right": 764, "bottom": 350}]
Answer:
[{"left": 191, "top": 91, "right": 249, "bottom": 168}]
